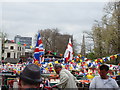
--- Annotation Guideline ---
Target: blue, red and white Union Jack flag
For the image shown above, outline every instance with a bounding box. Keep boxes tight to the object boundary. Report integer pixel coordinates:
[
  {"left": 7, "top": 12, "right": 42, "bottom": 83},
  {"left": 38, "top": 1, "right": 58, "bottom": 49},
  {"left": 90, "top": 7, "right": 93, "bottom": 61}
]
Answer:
[{"left": 34, "top": 33, "right": 45, "bottom": 63}]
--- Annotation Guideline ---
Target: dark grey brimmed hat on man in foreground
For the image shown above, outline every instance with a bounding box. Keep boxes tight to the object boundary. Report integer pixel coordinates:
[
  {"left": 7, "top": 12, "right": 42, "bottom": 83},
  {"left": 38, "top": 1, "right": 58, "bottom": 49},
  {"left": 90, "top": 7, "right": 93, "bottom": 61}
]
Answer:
[{"left": 18, "top": 64, "right": 42, "bottom": 82}]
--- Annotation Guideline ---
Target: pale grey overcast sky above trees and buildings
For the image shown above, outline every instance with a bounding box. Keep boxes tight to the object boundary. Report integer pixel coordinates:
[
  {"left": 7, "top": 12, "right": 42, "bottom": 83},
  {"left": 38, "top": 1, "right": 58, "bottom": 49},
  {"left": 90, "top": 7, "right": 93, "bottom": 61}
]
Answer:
[{"left": 0, "top": 1, "right": 110, "bottom": 46}]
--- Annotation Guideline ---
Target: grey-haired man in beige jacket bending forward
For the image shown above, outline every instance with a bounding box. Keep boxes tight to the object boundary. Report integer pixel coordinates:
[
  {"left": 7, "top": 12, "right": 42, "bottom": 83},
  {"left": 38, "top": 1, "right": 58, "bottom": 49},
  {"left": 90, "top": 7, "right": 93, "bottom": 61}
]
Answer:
[{"left": 52, "top": 64, "right": 77, "bottom": 90}]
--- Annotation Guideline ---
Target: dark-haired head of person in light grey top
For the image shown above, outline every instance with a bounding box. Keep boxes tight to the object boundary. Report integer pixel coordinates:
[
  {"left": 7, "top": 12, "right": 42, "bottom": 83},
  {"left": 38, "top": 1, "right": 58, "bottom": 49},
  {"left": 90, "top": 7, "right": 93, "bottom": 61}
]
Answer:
[{"left": 99, "top": 64, "right": 109, "bottom": 79}]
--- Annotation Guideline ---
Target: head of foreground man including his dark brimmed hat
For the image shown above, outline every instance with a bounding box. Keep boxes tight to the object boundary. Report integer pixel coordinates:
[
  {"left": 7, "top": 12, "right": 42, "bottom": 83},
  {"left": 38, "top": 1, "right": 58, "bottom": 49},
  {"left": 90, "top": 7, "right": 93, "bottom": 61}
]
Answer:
[{"left": 18, "top": 64, "right": 42, "bottom": 88}]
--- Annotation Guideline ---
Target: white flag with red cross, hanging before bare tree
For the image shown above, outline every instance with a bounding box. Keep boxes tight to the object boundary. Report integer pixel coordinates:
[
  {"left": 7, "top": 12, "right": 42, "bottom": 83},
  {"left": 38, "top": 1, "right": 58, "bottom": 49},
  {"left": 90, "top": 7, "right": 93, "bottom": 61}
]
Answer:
[{"left": 64, "top": 38, "right": 73, "bottom": 63}]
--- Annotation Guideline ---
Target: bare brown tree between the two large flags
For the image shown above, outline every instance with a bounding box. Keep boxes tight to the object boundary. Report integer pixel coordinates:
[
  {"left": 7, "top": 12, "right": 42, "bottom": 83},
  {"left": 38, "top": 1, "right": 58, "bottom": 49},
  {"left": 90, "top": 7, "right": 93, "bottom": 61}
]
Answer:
[{"left": 33, "top": 28, "right": 77, "bottom": 54}]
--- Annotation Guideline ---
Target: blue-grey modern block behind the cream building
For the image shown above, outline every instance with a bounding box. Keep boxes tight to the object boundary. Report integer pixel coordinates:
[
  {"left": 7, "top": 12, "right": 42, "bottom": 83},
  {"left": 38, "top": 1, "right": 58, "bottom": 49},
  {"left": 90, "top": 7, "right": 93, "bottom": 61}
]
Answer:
[{"left": 14, "top": 35, "right": 32, "bottom": 49}]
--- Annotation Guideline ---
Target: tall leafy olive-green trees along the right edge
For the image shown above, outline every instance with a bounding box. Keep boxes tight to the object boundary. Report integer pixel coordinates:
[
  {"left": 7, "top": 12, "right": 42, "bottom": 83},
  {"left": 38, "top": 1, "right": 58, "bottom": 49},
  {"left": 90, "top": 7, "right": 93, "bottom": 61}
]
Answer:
[{"left": 88, "top": 1, "right": 120, "bottom": 64}]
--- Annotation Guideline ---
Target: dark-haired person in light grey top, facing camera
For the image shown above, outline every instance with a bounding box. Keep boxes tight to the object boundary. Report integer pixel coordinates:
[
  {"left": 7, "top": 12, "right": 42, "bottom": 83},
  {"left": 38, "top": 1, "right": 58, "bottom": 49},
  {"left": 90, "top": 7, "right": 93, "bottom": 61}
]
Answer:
[{"left": 89, "top": 64, "right": 119, "bottom": 90}]
